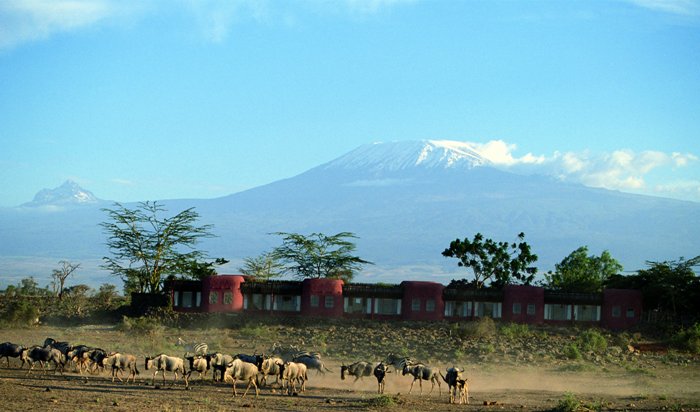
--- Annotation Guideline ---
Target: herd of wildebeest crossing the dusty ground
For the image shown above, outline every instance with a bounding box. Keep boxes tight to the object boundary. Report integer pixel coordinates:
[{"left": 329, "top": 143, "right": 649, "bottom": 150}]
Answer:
[{"left": 0, "top": 338, "right": 469, "bottom": 404}]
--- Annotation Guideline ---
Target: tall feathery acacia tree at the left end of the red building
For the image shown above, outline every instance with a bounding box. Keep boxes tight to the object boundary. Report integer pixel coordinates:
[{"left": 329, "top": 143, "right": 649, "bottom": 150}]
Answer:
[{"left": 100, "top": 201, "right": 213, "bottom": 293}]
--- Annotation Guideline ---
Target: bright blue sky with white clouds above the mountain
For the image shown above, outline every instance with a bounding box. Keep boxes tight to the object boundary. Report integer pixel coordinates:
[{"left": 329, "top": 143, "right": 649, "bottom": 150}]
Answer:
[{"left": 0, "top": 0, "right": 700, "bottom": 207}]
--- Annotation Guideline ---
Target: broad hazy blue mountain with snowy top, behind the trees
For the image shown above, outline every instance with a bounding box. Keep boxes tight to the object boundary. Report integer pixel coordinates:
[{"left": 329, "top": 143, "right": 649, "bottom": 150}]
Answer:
[{"left": 0, "top": 141, "right": 700, "bottom": 288}]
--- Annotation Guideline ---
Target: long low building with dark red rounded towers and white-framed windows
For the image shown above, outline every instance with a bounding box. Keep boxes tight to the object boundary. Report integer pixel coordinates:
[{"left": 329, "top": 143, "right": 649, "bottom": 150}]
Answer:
[{"left": 166, "top": 275, "right": 642, "bottom": 329}]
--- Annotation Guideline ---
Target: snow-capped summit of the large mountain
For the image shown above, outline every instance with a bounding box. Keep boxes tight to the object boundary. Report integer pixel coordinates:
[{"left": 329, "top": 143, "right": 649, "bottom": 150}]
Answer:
[{"left": 324, "top": 140, "right": 491, "bottom": 172}]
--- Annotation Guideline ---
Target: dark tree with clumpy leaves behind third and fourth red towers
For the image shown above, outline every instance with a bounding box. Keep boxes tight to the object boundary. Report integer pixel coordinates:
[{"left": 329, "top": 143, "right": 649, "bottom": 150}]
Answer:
[{"left": 442, "top": 233, "right": 537, "bottom": 288}]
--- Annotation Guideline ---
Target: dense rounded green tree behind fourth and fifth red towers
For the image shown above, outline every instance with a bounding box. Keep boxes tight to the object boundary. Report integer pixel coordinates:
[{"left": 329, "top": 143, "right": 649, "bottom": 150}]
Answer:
[{"left": 545, "top": 246, "right": 623, "bottom": 293}]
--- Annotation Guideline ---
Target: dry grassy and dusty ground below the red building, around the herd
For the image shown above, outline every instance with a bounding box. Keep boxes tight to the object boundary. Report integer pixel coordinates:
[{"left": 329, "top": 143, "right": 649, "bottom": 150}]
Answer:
[{"left": 0, "top": 317, "right": 700, "bottom": 412}]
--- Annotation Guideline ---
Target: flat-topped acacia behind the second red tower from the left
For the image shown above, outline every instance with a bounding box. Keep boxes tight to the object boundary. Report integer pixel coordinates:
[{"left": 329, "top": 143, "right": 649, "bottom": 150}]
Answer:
[{"left": 272, "top": 232, "right": 372, "bottom": 282}]
